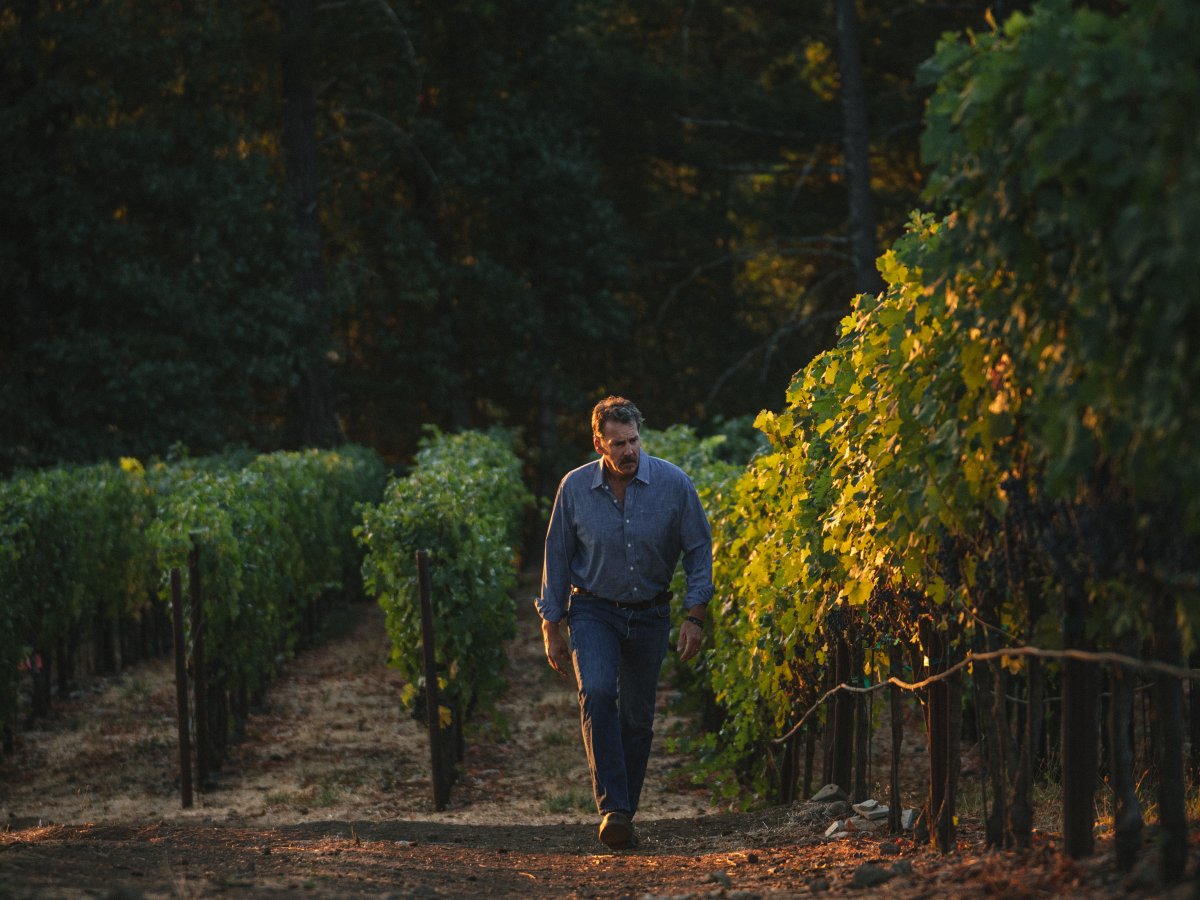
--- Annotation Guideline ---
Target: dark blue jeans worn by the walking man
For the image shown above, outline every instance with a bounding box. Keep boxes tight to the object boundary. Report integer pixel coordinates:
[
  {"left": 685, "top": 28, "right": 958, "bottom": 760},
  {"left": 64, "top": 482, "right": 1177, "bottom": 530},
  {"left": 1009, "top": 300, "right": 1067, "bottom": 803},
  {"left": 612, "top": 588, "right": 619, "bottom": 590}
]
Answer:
[{"left": 566, "top": 596, "right": 671, "bottom": 816}]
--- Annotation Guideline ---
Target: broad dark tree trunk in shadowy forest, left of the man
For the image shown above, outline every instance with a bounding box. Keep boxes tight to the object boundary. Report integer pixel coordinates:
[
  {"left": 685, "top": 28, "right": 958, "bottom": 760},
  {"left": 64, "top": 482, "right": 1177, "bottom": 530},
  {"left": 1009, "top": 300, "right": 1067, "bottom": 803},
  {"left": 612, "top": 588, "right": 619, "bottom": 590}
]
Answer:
[{"left": 280, "top": 0, "right": 341, "bottom": 446}]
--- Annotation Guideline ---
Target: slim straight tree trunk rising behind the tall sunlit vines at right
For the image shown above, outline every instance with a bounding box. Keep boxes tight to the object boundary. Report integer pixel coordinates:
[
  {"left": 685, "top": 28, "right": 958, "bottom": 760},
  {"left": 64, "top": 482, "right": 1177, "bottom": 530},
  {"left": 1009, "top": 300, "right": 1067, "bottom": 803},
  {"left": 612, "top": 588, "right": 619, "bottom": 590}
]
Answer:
[{"left": 836, "top": 0, "right": 883, "bottom": 294}]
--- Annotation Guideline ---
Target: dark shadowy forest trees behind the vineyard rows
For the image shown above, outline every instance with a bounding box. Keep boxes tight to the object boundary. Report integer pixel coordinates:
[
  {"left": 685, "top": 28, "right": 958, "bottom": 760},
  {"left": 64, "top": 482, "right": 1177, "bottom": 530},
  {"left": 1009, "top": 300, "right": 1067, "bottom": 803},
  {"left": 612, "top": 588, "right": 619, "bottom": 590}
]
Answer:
[{"left": 0, "top": 0, "right": 986, "bottom": 480}]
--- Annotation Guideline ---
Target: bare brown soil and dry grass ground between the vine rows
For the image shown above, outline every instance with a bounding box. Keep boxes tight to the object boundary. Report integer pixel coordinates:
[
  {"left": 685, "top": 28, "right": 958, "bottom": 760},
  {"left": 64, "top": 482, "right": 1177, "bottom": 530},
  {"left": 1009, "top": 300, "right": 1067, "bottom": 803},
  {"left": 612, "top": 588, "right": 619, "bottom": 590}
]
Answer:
[{"left": 0, "top": 580, "right": 1200, "bottom": 898}]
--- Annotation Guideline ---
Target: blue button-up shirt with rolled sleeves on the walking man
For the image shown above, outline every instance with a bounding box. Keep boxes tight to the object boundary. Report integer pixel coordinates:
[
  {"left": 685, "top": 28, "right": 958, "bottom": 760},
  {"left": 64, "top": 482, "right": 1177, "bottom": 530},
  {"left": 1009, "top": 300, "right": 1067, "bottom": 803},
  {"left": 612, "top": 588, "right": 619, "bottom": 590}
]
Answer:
[{"left": 536, "top": 450, "right": 713, "bottom": 622}]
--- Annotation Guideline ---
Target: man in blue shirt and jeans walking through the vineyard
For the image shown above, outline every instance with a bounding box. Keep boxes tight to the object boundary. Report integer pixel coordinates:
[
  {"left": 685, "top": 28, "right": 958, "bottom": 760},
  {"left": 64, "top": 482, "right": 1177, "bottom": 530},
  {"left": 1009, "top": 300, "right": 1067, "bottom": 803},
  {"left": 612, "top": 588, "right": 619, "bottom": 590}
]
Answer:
[{"left": 536, "top": 397, "right": 713, "bottom": 850}]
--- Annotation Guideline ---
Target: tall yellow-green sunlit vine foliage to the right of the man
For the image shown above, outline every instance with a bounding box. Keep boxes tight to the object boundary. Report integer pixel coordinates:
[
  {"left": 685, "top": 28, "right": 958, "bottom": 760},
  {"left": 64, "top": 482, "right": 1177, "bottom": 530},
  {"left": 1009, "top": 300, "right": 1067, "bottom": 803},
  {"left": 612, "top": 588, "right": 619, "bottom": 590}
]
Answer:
[{"left": 686, "top": 0, "right": 1200, "bottom": 801}]
